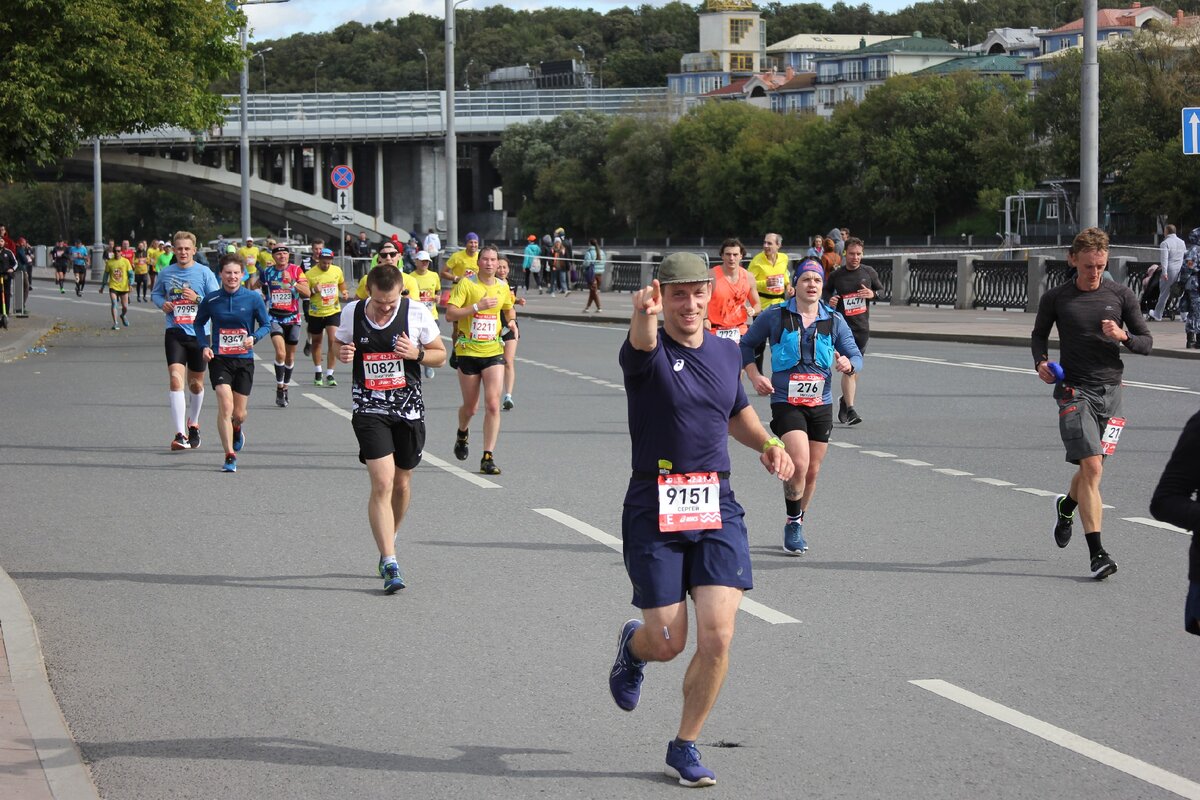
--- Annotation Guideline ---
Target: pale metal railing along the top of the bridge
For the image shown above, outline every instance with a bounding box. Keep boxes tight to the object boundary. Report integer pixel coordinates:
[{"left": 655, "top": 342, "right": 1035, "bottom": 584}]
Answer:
[{"left": 109, "top": 88, "right": 672, "bottom": 144}]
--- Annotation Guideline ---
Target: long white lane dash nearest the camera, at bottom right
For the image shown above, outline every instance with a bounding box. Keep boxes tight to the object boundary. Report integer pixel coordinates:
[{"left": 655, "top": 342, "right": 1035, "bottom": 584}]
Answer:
[{"left": 908, "top": 680, "right": 1200, "bottom": 800}]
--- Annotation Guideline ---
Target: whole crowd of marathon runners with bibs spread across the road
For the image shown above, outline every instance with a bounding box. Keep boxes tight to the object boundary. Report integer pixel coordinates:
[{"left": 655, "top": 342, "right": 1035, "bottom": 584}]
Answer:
[{"left": 39, "top": 228, "right": 1200, "bottom": 787}]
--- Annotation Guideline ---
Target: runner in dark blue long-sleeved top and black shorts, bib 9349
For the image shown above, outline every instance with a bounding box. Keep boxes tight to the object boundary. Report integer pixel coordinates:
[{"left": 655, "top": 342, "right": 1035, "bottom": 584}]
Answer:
[{"left": 196, "top": 253, "right": 271, "bottom": 473}]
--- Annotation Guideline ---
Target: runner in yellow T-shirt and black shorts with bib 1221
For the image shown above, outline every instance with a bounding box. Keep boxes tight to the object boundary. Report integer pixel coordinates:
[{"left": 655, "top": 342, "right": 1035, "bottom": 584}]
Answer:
[{"left": 446, "top": 245, "right": 517, "bottom": 475}]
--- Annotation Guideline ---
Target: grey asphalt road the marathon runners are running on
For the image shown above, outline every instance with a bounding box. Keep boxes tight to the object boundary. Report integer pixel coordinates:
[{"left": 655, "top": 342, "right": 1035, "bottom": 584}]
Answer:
[{"left": 0, "top": 295, "right": 1200, "bottom": 800}]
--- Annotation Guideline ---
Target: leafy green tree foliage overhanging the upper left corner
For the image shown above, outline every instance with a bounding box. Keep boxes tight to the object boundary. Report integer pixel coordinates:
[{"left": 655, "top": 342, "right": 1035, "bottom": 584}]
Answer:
[{"left": 0, "top": 0, "right": 242, "bottom": 179}]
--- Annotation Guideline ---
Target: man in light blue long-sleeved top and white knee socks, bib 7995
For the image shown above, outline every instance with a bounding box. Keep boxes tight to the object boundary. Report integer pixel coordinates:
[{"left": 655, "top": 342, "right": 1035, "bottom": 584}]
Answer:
[{"left": 150, "top": 230, "right": 221, "bottom": 450}]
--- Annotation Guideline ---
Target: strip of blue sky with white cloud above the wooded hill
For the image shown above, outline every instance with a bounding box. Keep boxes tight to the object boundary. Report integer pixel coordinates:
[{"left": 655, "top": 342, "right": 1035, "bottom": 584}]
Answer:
[{"left": 245, "top": 0, "right": 913, "bottom": 40}]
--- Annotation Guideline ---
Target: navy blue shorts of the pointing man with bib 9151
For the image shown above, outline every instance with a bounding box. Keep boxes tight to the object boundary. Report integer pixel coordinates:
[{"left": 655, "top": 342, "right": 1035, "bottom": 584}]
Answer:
[{"left": 620, "top": 479, "right": 754, "bottom": 608}]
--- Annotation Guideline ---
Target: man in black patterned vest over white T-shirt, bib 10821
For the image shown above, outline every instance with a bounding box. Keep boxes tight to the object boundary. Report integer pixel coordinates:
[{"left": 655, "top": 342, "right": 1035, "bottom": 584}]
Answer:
[{"left": 337, "top": 262, "right": 445, "bottom": 595}]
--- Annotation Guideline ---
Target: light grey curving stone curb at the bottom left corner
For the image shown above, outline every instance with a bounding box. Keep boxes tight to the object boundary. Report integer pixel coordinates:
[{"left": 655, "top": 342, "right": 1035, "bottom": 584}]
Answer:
[{"left": 0, "top": 569, "right": 100, "bottom": 800}]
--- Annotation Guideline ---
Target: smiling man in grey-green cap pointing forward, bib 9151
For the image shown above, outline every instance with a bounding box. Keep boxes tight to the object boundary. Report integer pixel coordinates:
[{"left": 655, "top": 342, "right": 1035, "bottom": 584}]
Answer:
[{"left": 608, "top": 253, "right": 792, "bottom": 787}]
